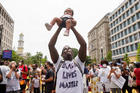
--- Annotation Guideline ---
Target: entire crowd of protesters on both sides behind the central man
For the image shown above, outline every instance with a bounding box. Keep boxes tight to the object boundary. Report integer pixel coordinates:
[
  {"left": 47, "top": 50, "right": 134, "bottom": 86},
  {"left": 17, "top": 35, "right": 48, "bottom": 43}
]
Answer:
[{"left": 0, "top": 60, "right": 140, "bottom": 93}]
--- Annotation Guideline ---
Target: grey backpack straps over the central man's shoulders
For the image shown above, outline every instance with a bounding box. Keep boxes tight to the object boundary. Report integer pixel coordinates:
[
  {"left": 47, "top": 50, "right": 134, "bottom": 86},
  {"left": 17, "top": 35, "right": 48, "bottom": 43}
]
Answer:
[{"left": 53, "top": 60, "right": 84, "bottom": 89}]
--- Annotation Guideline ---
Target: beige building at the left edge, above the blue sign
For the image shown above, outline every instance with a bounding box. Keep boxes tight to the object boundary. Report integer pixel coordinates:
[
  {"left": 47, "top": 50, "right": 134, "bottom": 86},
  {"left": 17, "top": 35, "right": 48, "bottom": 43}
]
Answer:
[{"left": 0, "top": 3, "right": 14, "bottom": 52}]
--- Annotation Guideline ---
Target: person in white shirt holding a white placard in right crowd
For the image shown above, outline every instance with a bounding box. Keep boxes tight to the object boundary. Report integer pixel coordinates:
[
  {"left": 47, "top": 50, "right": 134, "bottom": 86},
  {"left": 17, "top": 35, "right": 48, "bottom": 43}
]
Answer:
[{"left": 108, "top": 63, "right": 121, "bottom": 93}]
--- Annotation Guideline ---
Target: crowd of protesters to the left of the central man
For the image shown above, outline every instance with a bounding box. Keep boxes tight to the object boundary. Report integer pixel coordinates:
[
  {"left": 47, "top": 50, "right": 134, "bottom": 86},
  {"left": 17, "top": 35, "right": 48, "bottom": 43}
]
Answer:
[{"left": 0, "top": 61, "right": 55, "bottom": 93}]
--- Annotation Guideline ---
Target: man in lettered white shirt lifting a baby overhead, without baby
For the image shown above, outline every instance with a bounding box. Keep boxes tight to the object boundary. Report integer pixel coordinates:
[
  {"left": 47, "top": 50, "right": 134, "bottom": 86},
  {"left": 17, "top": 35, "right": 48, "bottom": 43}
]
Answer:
[{"left": 48, "top": 27, "right": 86, "bottom": 93}]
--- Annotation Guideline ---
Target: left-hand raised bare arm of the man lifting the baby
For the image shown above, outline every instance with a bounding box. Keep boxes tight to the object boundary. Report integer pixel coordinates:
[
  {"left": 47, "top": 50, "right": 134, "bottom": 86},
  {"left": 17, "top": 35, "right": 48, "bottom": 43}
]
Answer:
[{"left": 48, "top": 27, "right": 62, "bottom": 63}]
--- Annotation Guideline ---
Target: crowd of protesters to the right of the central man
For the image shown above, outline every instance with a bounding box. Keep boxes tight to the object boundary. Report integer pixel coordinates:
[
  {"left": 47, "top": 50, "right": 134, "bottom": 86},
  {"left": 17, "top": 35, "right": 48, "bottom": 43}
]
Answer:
[{"left": 84, "top": 60, "right": 140, "bottom": 93}]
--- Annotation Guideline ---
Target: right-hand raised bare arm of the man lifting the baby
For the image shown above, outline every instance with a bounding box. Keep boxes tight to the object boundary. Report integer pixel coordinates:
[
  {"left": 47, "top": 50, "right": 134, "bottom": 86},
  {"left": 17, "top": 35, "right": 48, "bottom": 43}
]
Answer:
[{"left": 71, "top": 27, "right": 87, "bottom": 62}]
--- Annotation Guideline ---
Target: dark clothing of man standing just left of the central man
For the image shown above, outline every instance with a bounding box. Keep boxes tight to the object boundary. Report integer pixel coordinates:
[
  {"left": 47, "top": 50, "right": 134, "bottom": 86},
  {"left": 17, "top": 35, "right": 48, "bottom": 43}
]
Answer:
[{"left": 45, "top": 69, "right": 54, "bottom": 90}]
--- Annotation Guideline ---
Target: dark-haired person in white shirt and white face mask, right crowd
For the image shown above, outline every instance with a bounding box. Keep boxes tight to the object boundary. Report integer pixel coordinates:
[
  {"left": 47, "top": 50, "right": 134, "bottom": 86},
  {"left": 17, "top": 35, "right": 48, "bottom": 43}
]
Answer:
[{"left": 98, "top": 60, "right": 110, "bottom": 93}]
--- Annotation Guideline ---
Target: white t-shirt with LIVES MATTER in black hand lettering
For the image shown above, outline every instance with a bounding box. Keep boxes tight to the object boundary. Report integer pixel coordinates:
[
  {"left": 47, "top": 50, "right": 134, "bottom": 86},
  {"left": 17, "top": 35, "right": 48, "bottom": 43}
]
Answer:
[{"left": 55, "top": 56, "right": 84, "bottom": 93}]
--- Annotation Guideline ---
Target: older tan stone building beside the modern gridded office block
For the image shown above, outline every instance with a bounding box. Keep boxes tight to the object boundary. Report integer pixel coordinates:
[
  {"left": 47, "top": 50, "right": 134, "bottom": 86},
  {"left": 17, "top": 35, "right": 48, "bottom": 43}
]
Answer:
[{"left": 88, "top": 13, "right": 111, "bottom": 63}]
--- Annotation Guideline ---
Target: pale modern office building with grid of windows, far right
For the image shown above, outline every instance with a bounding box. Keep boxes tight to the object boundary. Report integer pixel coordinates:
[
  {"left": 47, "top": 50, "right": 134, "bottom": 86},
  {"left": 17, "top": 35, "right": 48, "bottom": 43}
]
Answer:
[{"left": 109, "top": 0, "right": 140, "bottom": 62}]
